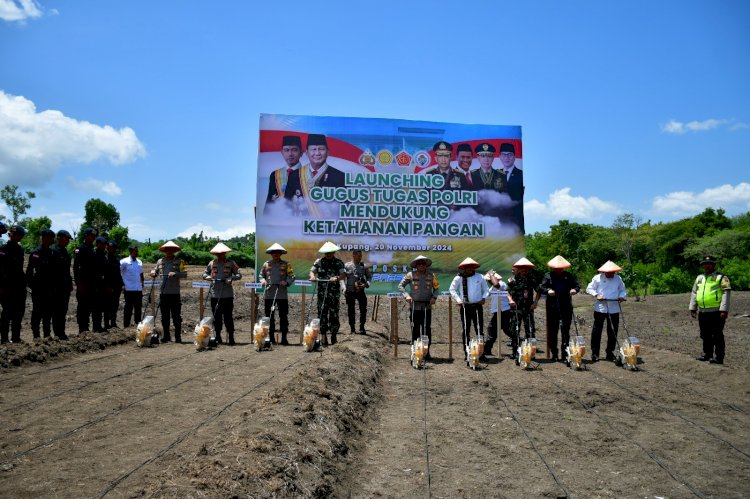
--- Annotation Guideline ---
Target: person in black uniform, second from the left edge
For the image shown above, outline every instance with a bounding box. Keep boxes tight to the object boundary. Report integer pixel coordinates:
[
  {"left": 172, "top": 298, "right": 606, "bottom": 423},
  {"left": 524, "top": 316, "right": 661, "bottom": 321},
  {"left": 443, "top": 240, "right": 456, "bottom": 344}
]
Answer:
[{"left": 26, "top": 229, "right": 56, "bottom": 338}]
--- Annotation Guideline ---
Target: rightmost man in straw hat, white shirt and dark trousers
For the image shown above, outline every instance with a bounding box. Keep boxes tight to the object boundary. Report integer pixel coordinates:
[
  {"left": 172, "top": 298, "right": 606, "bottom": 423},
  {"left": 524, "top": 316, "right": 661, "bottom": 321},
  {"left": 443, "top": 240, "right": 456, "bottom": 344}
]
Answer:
[{"left": 586, "top": 260, "right": 627, "bottom": 362}]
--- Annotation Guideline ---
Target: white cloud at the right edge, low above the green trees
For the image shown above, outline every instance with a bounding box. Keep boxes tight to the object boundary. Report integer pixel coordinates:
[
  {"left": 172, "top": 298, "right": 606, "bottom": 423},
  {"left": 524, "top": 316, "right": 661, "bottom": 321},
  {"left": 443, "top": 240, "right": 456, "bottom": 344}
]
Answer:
[{"left": 651, "top": 182, "right": 750, "bottom": 215}]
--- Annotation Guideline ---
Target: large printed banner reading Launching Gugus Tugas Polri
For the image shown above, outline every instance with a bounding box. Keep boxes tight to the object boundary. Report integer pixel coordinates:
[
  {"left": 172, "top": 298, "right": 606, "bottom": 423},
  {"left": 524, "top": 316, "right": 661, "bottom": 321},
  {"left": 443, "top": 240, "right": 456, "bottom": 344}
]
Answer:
[{"left": 256, "top": 114, "right": 524, "bottom": 294}]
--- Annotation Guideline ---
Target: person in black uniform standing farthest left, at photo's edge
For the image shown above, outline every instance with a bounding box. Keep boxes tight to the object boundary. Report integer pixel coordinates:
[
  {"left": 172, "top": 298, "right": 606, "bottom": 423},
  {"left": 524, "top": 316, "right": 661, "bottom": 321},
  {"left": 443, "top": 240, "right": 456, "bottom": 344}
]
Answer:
[{"left": 0, "top": 224, "right": 26, "bottom": 343}]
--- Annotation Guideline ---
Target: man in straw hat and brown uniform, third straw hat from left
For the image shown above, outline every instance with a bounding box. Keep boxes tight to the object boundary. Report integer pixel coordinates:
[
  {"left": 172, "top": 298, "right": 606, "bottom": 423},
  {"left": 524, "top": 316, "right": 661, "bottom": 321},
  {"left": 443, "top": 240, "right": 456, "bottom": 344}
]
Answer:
[{"left": 260, "top": 243, "right": 294, "bottom": 345}]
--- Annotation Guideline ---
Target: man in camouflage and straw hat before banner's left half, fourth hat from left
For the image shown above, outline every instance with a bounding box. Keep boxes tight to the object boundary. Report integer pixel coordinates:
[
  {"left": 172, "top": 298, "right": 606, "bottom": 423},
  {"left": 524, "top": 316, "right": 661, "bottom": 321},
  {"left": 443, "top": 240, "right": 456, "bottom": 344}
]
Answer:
[{"left": 310, "top": 241, "right": 346, "bottom": 346}]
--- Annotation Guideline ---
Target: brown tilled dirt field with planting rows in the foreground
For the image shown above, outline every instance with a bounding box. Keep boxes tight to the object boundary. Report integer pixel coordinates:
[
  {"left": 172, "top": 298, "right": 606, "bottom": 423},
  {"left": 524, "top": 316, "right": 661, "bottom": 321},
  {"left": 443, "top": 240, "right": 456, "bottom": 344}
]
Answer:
[{"left": 0, "top": 271, "right": 750, "bottom": 498}]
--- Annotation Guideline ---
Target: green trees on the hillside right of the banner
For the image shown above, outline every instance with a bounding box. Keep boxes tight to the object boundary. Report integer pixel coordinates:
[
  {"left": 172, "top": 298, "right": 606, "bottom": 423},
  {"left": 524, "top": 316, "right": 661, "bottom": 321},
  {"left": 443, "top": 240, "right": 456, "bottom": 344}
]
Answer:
[{"left": 526, "top": 208, "right": 750, "bottom": 296}]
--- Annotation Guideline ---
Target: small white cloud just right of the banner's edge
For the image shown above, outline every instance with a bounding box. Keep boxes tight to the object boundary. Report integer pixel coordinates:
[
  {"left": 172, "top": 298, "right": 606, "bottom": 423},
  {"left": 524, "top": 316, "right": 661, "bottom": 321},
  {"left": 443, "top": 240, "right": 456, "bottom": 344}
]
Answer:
[{"left": 523, "top": 187, "right": 622, "bottom": 221}]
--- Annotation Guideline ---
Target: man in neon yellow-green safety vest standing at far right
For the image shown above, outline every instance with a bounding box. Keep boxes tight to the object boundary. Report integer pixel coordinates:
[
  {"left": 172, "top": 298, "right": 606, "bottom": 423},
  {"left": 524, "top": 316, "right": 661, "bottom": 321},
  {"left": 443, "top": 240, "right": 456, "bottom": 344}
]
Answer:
[{"left": 689, "top": 255, "right": 732, "bottom": 364}]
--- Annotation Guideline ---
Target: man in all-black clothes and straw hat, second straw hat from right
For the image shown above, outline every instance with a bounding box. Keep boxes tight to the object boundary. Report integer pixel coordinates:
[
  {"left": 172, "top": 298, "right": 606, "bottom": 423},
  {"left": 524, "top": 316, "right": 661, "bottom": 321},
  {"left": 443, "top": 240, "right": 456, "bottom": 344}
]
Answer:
[{"left": 541, "top": 255, "right": 581, "bottom": 362}]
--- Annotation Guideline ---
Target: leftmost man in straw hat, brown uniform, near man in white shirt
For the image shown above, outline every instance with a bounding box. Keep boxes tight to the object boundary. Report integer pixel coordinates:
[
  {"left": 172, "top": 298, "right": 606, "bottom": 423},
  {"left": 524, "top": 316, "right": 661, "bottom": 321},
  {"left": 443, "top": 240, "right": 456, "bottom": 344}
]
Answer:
[{"left": 151, "top": 241, "right": 187, "bottom": 343}]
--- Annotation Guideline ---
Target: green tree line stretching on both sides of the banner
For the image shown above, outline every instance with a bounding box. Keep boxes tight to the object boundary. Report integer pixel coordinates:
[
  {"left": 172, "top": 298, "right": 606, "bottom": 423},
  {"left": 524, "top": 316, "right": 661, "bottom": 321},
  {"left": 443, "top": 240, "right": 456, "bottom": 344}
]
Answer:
[{"left": 0, "top": 185, "right": 750, "bottom": 296}]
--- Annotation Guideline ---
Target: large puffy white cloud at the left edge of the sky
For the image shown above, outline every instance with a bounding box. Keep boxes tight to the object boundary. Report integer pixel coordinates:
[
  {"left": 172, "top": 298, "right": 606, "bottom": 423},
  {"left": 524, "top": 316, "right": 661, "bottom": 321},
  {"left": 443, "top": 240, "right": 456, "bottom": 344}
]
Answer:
[{"left": 0, "top": 91, "right": 146, "bottom": 185}]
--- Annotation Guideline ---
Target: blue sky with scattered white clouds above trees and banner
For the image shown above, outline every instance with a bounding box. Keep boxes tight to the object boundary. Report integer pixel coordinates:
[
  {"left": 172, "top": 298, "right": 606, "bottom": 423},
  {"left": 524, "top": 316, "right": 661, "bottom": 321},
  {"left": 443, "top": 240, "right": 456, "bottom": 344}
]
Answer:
[{"left": 0, "top": 0, "right": 750, "bottom": 240}]
